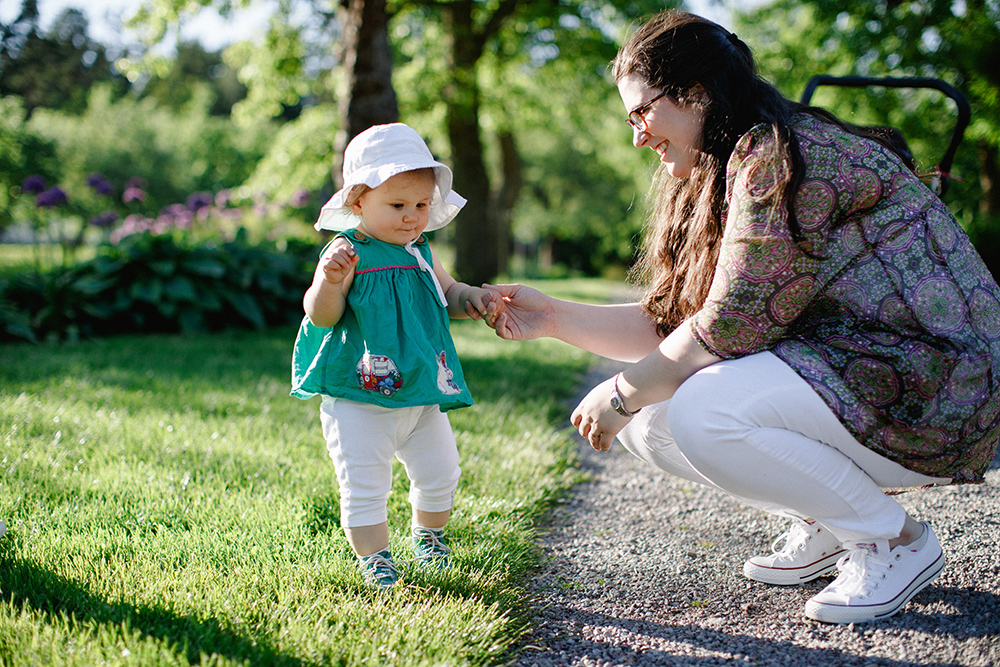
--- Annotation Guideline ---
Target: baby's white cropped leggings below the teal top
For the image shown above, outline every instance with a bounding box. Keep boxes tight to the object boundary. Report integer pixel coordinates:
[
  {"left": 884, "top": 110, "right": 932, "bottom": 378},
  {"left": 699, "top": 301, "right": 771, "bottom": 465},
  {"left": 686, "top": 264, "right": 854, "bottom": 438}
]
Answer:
[{"left": 320, "top": 396, "right": 462, "bottom": 528}]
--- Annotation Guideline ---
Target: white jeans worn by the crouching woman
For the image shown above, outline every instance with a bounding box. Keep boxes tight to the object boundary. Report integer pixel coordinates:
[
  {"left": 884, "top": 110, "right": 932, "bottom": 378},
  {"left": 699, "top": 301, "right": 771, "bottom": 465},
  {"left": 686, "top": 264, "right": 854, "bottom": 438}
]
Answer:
[{"left": 618, "top": 352, "right": 949, "bottom": 543}]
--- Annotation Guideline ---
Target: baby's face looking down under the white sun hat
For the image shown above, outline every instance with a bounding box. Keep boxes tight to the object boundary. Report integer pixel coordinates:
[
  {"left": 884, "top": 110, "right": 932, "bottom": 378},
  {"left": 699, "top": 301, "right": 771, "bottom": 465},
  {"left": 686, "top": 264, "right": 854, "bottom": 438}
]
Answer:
[{"left": 351, "top": 169, "right": 434, "bottom": 245}]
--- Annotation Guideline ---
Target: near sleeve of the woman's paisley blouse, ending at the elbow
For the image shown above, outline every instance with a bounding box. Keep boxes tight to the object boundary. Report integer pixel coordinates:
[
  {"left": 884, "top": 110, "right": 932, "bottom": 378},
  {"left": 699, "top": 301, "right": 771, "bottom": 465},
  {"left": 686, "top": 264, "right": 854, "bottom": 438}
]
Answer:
[{"left": 690, "top": 126, "right": 837, "bottom": 358}]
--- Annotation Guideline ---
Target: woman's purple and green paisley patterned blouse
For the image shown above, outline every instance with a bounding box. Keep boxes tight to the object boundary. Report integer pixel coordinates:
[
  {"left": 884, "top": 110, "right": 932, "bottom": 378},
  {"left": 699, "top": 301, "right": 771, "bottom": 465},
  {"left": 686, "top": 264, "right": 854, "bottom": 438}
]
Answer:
[{"left": 691, "top": 114, "right": 1000, "bottom": 482}]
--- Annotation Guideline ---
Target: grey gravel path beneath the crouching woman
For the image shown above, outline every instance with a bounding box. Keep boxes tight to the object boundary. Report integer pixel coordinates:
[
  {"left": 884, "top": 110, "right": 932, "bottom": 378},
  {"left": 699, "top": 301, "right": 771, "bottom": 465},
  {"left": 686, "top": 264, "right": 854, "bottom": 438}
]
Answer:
[{"left": 512, "top": 354, "right": 1000, "bottom": 667}]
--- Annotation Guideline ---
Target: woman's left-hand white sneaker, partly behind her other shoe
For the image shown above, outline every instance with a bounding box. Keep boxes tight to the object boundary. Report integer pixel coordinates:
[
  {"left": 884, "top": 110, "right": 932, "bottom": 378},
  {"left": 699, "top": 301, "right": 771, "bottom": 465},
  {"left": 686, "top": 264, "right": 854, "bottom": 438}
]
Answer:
[{"left": 743, "top": 520, "right": 846, "bottom": 586}]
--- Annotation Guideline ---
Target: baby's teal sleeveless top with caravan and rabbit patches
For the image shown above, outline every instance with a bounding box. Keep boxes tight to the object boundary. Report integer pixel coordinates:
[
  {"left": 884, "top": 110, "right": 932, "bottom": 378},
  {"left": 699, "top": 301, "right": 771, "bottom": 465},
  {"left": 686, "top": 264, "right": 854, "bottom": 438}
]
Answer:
[{"left": 291, "top": 229, "right": 473, "bottom": 411}]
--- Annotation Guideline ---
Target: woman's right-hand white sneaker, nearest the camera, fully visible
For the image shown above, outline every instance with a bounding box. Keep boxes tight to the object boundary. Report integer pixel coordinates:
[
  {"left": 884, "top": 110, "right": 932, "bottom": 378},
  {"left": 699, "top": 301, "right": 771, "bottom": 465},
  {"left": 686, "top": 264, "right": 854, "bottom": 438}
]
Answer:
[{"left": 806, "top": 523, "right": 944, "bottom": 623}]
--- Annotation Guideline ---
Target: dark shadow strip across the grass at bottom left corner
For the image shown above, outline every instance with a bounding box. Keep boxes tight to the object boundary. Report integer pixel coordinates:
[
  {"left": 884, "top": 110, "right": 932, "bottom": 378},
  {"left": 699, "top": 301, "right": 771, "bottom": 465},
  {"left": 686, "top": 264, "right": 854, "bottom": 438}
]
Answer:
[{"left": 0, "top": 534, "right": 313, "bottom": 667}]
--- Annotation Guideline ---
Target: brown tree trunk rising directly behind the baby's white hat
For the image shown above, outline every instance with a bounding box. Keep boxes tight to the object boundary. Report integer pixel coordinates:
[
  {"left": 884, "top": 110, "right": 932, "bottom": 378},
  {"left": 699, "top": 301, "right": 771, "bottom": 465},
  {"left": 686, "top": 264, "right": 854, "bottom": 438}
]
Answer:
[{"left": 333, "top": 0, "right": 399, "bottom": 188}]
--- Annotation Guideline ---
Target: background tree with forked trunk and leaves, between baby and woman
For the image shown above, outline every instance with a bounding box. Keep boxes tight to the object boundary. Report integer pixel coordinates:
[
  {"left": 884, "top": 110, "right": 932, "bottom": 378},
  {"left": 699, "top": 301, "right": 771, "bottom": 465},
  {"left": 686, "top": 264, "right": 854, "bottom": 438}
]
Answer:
[{"left": 390, "top": 0, "right": 671, "bottom": 284}]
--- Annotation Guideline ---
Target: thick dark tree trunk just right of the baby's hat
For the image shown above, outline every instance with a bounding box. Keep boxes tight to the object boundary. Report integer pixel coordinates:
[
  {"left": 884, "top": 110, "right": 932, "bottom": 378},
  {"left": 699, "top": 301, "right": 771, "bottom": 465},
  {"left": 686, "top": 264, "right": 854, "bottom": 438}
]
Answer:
[{"left": 442, "top": 0, "right": 499, "bottom": 285}]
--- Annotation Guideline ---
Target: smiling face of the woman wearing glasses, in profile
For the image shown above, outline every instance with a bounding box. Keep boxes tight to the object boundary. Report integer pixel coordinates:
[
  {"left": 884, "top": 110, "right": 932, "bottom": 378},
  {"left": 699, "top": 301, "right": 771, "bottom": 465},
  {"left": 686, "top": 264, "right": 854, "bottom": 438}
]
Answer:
[{"left": 618, "top": 74, "right": 705, "bottom": 178}]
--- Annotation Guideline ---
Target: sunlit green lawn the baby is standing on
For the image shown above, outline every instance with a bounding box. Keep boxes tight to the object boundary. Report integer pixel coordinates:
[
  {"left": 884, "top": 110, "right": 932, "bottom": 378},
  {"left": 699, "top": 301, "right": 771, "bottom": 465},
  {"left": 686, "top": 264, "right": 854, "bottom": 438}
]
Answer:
[{"left": 0, "top": 281, "right": 616, "bottom": 667}]
